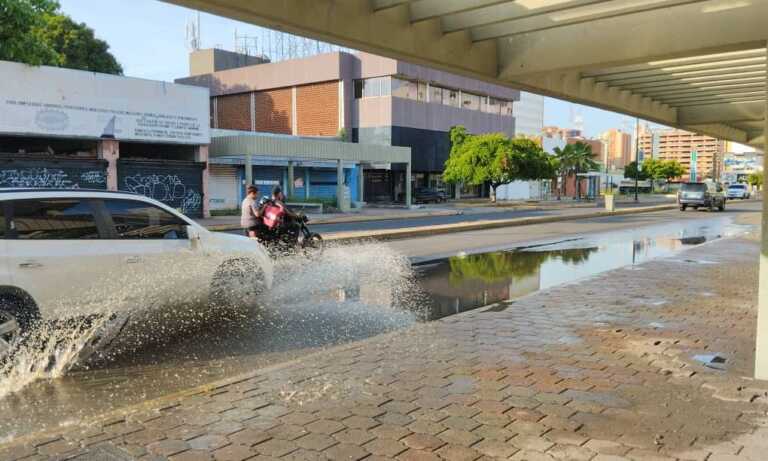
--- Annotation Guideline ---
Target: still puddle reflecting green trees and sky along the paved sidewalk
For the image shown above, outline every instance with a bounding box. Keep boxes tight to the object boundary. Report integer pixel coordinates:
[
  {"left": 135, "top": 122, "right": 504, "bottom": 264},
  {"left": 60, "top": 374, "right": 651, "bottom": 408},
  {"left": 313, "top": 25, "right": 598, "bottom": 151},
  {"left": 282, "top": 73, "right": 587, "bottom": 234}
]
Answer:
[{"left": 416, "top": 219, "right": 745, "bottom": 320}]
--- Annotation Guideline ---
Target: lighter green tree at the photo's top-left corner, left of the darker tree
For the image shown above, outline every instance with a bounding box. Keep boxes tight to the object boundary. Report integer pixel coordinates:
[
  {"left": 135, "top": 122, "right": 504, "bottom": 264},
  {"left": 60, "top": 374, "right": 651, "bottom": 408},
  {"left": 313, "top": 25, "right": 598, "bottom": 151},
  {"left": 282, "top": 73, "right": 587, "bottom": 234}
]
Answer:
[{"left": 0, "top": 0, "right": 59, "bottom": 66}]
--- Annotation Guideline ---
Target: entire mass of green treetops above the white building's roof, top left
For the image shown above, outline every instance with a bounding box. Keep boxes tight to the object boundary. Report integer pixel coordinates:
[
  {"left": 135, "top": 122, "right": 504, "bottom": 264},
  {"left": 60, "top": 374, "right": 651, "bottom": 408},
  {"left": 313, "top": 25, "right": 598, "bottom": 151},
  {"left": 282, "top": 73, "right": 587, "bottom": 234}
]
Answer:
[{"left": 0, "top": 0, "right": 123, "bottom": 74}]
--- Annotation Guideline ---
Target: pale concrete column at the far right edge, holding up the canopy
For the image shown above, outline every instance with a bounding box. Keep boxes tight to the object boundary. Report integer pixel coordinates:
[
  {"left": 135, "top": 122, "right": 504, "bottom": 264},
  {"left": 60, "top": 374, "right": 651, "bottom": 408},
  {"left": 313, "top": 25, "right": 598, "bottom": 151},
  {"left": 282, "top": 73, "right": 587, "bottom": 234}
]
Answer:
[{"left": 755, "top": 43, "right": 768, "bottom": 379}]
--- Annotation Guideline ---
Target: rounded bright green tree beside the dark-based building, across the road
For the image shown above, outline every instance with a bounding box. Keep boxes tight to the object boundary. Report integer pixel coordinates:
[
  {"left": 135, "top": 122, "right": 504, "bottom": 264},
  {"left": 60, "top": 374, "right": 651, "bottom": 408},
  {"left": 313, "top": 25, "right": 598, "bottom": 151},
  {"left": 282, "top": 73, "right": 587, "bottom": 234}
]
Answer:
[{"left": 443, "top": 126, "right": 553, "bottom": 202}]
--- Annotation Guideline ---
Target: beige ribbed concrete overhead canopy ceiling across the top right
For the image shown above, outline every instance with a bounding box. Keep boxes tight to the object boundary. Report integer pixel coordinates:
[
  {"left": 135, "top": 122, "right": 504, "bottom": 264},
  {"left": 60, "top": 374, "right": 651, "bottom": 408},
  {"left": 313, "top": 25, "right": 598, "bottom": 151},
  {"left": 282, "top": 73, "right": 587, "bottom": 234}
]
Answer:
[{"left": 167, "top": 0, "right": 768, "bottom": 146}]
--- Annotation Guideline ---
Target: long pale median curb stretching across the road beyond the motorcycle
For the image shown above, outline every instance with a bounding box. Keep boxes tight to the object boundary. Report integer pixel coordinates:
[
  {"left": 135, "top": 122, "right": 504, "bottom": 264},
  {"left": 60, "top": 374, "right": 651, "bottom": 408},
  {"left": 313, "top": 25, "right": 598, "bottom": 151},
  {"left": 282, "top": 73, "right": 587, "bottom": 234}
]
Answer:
[{"left": 323, "top": 204, "right": 677, "bottom": 243}]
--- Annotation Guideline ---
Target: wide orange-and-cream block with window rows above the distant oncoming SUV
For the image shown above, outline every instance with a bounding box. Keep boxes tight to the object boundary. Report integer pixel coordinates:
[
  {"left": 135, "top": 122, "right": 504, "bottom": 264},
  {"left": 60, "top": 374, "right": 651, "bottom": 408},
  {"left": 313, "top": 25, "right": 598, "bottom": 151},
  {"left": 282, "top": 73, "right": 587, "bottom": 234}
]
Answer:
[{"left": 639, "top": 127, "right": 725, "bottom": 181}]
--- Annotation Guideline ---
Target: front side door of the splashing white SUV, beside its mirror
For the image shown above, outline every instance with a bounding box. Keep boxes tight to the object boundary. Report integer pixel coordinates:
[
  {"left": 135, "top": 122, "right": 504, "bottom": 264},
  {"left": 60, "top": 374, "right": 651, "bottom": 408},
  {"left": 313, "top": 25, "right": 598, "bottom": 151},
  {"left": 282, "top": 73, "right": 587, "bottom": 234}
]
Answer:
[{"left": 100, "top": 198, "right": 210, "bottom": 310}]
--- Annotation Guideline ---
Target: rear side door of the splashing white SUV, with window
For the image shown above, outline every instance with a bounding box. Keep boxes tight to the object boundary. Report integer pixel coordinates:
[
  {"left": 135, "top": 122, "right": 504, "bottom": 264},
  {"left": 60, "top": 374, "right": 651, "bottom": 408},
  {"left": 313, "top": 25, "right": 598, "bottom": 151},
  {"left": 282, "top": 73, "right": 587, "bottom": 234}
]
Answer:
[{"left": 4, "top": 197, "right": 116, "bottom": 318}]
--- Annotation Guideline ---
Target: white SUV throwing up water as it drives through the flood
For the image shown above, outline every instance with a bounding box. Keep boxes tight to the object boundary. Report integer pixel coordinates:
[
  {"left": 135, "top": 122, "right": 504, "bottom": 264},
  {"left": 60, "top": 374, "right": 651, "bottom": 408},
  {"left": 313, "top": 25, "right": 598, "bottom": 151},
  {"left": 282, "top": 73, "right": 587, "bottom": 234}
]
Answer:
[{"left": 0, "top": 189, "right": 272, "bottom": 358}]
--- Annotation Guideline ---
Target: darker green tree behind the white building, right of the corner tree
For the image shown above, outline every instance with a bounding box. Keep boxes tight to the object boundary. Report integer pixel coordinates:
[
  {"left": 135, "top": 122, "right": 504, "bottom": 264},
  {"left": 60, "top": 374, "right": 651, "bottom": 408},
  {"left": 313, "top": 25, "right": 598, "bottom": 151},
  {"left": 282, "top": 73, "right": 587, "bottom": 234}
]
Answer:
[{"left": 39, "top": 14, "right": 123, "bottom": 75}]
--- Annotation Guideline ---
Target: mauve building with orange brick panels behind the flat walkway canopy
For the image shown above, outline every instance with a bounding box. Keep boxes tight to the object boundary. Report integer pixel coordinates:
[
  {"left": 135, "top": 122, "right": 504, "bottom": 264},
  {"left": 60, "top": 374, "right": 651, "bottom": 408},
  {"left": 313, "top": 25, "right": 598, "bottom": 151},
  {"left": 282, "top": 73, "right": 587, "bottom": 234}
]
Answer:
[{"left": 176, "top": 52, "right": 519, "bottom": 202}]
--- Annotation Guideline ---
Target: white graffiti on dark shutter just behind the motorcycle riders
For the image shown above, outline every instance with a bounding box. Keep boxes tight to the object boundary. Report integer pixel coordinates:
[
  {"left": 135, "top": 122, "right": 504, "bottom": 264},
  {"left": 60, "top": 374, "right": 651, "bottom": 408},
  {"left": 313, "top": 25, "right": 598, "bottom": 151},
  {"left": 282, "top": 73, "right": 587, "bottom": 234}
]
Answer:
[{"left": 123, "top": 173, "right": 203, "bottom": 214}]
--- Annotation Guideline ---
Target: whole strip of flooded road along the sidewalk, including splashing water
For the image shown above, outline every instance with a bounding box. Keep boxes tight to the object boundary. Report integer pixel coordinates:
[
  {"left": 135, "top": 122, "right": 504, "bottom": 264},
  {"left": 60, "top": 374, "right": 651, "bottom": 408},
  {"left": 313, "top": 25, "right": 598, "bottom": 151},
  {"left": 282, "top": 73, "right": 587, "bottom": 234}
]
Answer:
[{"left": 0, "top": 217, "right": 744, "bottom": 441}]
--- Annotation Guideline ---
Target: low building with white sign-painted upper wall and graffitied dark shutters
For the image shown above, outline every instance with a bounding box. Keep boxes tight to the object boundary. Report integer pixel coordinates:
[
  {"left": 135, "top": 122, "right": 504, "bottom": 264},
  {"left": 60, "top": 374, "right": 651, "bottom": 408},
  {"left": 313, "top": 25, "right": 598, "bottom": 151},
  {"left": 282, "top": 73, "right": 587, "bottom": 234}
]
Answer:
[{"left": 0, "top": 61, "right": 210, "bottom": 217}]
